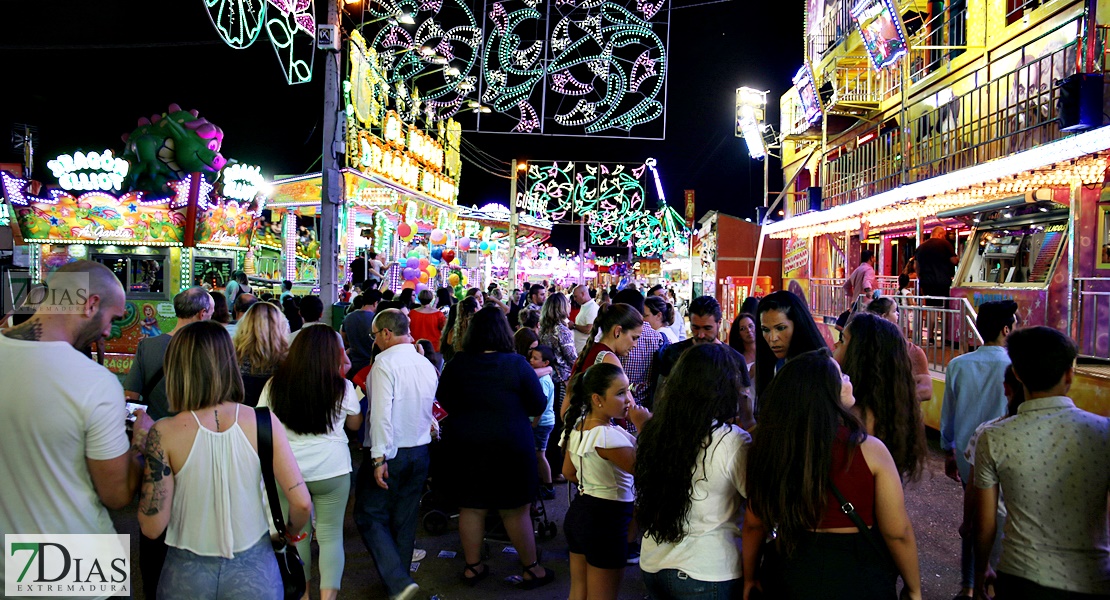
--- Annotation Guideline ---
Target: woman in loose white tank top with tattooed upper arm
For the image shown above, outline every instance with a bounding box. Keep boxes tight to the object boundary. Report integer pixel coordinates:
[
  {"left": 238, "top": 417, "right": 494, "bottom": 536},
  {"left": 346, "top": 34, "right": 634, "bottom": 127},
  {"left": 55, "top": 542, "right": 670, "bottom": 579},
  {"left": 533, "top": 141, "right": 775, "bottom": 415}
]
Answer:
[{"left": 139, "top": 322, "right": 312, "bottom": 600}]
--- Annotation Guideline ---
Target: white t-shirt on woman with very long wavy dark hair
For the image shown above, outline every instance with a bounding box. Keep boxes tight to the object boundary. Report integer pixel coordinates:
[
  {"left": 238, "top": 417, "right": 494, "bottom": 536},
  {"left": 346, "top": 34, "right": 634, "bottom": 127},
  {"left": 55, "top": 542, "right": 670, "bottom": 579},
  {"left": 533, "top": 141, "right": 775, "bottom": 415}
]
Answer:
[{"left": 639, "top": 425, "right": 751, "bottom": 581}]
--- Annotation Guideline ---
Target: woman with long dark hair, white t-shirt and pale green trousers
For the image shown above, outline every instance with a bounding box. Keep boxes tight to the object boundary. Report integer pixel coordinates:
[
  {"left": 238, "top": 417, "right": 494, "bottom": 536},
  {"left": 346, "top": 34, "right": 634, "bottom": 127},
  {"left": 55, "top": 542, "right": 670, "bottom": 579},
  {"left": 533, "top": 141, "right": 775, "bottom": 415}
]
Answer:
[{"left": 259, "top": 326, "right": 362, "bottom": 600}]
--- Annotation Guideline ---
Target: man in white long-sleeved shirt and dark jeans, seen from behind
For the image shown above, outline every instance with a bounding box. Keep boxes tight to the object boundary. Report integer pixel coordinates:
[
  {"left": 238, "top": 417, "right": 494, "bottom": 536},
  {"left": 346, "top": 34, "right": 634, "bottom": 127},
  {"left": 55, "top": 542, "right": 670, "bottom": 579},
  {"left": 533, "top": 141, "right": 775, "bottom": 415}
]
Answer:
[{"left": 354, "top": 308, "right": 438, "bottom": 600}]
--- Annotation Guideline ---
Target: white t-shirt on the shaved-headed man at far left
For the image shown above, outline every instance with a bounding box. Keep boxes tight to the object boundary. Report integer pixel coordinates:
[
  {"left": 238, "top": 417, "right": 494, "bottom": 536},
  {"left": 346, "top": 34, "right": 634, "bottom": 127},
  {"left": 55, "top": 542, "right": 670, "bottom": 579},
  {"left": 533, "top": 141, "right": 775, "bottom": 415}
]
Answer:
[{"left": 0, "top": 334, "right": 130, "bottom": 541}]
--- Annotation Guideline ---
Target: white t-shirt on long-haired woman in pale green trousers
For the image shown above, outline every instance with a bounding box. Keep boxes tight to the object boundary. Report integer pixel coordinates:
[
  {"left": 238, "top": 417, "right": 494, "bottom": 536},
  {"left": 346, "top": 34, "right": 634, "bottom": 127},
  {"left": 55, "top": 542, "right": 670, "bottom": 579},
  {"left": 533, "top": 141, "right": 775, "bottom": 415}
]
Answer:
[{"left": 259, "top": 379, "right": 362, "bottom": 481}]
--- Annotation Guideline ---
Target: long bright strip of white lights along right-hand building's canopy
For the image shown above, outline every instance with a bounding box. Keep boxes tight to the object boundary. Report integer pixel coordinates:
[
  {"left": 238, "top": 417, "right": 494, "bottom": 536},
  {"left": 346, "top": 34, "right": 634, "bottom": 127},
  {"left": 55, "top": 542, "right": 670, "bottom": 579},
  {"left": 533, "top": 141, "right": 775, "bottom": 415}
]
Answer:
[{"left": 763, "top": 128, "right": 1110, "bottom": 238}]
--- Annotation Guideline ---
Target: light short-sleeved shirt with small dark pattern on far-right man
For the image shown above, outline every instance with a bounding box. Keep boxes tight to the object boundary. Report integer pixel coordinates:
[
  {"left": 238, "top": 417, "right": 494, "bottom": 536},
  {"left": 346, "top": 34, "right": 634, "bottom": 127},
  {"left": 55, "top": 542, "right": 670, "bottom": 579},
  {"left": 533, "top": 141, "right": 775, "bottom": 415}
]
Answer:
[{"left": 975, "top": 396, "right": 1110, "bottom": 594}]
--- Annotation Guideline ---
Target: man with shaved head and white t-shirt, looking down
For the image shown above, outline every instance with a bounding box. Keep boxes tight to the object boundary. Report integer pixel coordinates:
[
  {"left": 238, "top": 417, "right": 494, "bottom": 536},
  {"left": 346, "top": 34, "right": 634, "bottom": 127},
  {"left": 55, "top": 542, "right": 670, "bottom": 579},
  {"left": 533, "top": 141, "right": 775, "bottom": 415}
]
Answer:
[{"left": 0, "top": 261, "right": 152, "bottom": 586}]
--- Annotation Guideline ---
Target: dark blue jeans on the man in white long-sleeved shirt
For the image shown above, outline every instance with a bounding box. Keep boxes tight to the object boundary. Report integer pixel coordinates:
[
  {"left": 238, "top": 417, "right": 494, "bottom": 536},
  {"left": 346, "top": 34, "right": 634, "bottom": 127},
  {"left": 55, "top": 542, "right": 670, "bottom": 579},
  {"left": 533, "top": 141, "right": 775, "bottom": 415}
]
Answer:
[{"left": 354, "top": 446, "right": 428, "bottom": 598}]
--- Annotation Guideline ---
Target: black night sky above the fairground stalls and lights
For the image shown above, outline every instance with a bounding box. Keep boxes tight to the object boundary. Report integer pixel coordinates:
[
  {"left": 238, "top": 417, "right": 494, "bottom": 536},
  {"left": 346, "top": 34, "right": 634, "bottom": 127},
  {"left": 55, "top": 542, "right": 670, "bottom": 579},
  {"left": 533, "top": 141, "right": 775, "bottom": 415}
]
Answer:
[{"left": 0, "top": 0, "right": 803, "bottom": 253}]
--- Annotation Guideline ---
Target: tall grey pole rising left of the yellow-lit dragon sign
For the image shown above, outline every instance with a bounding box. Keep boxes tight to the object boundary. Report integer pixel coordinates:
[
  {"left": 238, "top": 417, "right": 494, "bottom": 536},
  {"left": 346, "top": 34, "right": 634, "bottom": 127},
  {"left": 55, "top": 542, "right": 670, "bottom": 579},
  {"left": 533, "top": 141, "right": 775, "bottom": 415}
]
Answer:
[{"left": 319, "top": 0, "right": 343, "bottom": 323}]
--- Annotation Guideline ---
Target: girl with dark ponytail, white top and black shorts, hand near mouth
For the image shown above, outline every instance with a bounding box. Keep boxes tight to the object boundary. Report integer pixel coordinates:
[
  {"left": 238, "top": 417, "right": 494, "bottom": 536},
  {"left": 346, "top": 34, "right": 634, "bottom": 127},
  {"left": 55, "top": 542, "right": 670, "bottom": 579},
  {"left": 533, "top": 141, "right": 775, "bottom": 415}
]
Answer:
[{"left": 561, "top": 362, "right": 650, "bottom": 600}]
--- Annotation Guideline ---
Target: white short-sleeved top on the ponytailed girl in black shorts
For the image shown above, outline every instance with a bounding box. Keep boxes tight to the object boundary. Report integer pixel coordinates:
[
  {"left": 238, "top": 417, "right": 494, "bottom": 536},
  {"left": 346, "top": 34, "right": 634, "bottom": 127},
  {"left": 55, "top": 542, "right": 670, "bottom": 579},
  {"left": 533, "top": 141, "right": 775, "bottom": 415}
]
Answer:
[{"left": 563, "top": 425, "right": 636, "bottom": 502}]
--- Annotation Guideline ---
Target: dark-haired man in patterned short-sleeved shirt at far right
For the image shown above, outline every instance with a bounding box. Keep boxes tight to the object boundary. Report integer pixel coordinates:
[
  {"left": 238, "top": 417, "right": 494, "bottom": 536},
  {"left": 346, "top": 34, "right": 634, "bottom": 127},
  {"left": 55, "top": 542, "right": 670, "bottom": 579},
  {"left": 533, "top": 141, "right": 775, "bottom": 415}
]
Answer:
[{"left": 968, "top": 327, "right": 1110, "bottom": 600}]
